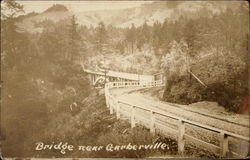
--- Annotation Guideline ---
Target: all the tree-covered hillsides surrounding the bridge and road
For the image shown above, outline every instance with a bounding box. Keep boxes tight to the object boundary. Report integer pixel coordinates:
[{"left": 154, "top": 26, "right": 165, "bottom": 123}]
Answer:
[{"left": 1, "top": 1, "right": 249, "bottom": 157}]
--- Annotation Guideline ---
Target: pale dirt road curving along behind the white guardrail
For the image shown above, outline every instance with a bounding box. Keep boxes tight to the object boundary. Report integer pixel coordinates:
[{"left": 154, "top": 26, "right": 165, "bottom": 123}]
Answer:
[{"left": 111, "top": 87, "right": 249, "bottom": 136}]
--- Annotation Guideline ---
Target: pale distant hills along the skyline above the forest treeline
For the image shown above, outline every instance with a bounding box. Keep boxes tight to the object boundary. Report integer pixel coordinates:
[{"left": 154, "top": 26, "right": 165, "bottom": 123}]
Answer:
[{"left": 19, "top": 1, "right": 239, "bottom": 32}]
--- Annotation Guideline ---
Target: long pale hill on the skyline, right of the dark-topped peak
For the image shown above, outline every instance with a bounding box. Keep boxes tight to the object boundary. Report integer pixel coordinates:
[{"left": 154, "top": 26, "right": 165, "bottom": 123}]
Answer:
[{"left": 76, "top": 1, "right": 239, "bottom": 27}]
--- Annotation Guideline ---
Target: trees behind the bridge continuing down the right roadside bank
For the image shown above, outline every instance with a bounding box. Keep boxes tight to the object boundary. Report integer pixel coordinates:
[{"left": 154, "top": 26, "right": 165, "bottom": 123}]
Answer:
[{"left": 73, "top": 2, "right": 249, "bottom": 113}]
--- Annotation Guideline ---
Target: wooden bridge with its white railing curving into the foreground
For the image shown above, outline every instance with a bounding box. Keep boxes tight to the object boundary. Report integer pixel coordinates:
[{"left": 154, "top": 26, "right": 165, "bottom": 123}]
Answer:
[{"left": 86, "top": 71, "right": 249, "bottom": 158}]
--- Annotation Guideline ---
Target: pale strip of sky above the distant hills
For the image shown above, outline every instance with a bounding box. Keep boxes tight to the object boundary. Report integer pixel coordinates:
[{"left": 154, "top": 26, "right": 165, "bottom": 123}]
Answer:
[{"left": 17, "top": 0, "right": 151, "bottom": 13}]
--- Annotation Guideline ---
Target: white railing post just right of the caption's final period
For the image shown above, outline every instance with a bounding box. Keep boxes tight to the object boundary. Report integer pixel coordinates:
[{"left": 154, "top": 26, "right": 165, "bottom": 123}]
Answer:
[{"left": 178, "top": 119, "right": 185, "bottom": 154}]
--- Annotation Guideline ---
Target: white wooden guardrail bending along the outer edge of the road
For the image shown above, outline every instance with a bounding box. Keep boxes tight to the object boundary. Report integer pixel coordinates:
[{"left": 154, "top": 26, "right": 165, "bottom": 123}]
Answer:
[{"left": 105, "top": 80, "right": 249, "bottom": 157}]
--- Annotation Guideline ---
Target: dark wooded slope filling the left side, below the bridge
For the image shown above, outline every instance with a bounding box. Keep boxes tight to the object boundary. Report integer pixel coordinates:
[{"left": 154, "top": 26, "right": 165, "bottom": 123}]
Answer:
[{"left": 0, "top": 1, "right": 162, "bottom": 158}]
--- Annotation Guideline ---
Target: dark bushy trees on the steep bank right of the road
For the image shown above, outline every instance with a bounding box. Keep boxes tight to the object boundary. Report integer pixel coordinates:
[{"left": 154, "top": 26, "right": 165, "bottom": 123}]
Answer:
[{"left": 162, "top": 5, "right": 248, "bottom": 113}]
